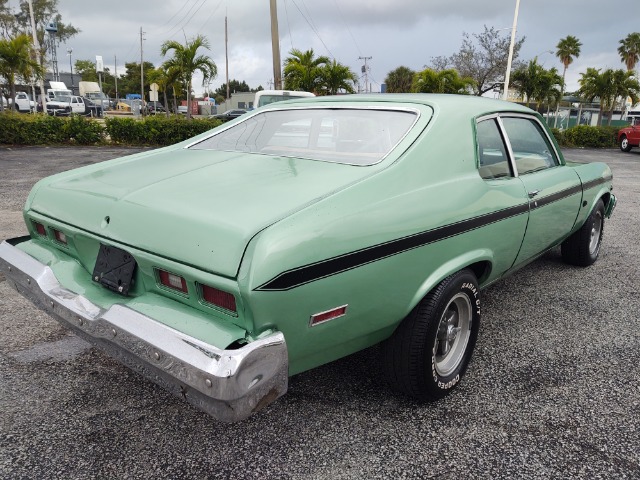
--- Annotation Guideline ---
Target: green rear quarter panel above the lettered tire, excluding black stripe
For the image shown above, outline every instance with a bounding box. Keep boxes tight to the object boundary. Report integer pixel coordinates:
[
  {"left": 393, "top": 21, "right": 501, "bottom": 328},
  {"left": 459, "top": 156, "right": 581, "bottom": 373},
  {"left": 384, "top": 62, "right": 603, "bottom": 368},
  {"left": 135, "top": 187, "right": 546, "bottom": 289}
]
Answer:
[{"left": 238, "top": 105, "right": 527, "bottom": 374}]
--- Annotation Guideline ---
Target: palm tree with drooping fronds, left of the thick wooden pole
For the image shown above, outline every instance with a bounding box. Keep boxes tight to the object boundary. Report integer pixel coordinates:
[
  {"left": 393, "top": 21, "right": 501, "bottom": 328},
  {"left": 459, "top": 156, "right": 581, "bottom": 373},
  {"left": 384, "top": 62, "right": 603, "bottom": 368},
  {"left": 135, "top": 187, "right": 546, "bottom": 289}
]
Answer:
[{"left": 160, "top": 35, "right": 218, "bottom": 119}]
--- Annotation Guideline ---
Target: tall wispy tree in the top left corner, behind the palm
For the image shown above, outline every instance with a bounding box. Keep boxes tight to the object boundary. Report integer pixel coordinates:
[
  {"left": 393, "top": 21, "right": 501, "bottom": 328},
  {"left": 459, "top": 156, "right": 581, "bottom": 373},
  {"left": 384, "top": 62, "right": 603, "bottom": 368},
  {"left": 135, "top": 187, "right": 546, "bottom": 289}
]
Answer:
[{"left": 0, "top": 0, "right": 80, "bottom": 65}]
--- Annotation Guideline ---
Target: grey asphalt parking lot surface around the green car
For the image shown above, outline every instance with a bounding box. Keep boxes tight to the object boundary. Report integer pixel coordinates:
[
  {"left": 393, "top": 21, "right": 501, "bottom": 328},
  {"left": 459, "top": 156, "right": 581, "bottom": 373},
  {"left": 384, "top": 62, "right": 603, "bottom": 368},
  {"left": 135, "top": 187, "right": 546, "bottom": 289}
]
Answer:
[{"left": 0, "top": 148, "right": 640, "bottom": 479}]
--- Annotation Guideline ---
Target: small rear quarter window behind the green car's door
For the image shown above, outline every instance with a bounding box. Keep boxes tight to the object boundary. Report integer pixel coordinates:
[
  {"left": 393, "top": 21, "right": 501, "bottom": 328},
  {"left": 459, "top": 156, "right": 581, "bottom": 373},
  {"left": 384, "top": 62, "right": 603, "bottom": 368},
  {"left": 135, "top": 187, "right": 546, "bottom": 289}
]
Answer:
[{"left": 476, "top": 118, "right": 511, "bottom": 180}]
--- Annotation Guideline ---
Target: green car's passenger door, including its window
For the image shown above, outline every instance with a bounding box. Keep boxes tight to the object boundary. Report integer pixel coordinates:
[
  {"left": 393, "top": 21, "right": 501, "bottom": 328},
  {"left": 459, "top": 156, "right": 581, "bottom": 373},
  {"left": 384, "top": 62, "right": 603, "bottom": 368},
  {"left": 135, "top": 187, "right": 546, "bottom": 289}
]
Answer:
[{"left": 500, "top": 115, "right": 582, "bottom": 266}]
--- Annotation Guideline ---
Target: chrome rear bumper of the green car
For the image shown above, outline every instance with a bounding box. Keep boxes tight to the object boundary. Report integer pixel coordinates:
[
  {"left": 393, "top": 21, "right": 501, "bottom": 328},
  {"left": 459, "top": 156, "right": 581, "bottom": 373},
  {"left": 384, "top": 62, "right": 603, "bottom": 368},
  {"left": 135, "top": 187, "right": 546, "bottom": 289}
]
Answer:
[{"left": 0, "top": 237, "right": 288, "bottom": 422}]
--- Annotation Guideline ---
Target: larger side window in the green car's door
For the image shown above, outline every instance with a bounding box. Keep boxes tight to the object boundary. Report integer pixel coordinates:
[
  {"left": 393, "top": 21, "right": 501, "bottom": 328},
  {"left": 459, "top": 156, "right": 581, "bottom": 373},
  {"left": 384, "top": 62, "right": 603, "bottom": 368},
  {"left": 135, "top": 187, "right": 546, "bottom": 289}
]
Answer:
[{"left": 502, "top": 117, "right": 559, "bottom": 175}]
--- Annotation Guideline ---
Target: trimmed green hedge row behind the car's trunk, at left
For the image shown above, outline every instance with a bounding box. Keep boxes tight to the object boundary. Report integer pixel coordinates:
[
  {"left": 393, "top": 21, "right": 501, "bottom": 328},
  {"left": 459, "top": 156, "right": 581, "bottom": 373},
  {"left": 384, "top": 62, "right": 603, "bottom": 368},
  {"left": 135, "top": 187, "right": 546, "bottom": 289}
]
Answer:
[{"left": 0, "top": 112, "right": 220, "bottom": 145}]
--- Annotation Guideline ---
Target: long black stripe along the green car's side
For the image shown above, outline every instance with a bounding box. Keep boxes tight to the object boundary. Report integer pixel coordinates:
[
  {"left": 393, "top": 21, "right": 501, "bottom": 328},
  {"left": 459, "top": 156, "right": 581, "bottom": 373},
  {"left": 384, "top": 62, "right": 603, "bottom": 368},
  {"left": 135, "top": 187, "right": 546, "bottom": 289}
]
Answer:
[{"left": 256, "top": 176, "right": 612, "bottom": 291}]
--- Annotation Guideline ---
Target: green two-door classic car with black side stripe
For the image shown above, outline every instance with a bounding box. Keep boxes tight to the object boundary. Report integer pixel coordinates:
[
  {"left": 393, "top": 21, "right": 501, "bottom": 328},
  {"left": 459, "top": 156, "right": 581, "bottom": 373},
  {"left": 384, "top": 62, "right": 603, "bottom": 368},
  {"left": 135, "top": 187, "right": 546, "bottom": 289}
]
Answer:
[{"left": 0, "top": 94, "right": 616, "bottom": 421}]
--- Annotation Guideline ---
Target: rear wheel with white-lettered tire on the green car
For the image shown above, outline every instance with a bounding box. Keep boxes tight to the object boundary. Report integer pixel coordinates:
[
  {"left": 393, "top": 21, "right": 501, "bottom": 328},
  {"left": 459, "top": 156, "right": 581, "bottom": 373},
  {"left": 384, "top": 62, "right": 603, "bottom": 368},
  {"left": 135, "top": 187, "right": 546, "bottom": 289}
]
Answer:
[{"left": 383, "top": 270, "right": 480, "bottom": 402}]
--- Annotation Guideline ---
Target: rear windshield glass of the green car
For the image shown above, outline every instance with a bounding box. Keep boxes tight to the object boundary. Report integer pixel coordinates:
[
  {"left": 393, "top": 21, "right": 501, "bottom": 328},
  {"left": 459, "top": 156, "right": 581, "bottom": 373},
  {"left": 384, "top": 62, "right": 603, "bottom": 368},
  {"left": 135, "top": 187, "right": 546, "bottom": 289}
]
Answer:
[{"left": 190, "top": 108, "right": 418, "bottom": 165}]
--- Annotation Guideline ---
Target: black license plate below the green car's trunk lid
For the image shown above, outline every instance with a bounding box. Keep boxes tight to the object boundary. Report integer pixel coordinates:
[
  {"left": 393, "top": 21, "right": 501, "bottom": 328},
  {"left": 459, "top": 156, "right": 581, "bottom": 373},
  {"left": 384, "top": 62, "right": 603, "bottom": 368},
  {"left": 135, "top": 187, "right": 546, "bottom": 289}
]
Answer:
[{"left": 93, "top": 244, "right": 137, "bottom": 296}]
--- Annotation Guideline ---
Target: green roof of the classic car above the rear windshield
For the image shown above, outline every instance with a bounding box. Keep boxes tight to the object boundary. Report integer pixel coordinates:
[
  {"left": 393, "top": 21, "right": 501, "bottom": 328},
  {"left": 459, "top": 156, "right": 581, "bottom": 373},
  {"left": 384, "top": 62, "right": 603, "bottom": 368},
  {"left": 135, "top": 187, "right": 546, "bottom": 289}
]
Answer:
[{"left": 263, "top": 93, "right": 533, "bottom": 117}]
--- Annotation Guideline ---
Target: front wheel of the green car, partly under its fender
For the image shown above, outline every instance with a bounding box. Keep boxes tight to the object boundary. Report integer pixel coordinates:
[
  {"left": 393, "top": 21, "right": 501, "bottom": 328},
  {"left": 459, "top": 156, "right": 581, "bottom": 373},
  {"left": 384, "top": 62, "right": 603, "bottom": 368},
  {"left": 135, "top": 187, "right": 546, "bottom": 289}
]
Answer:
[{"left": 561, "top": 199, "right": 604, "bottom": 267}]
